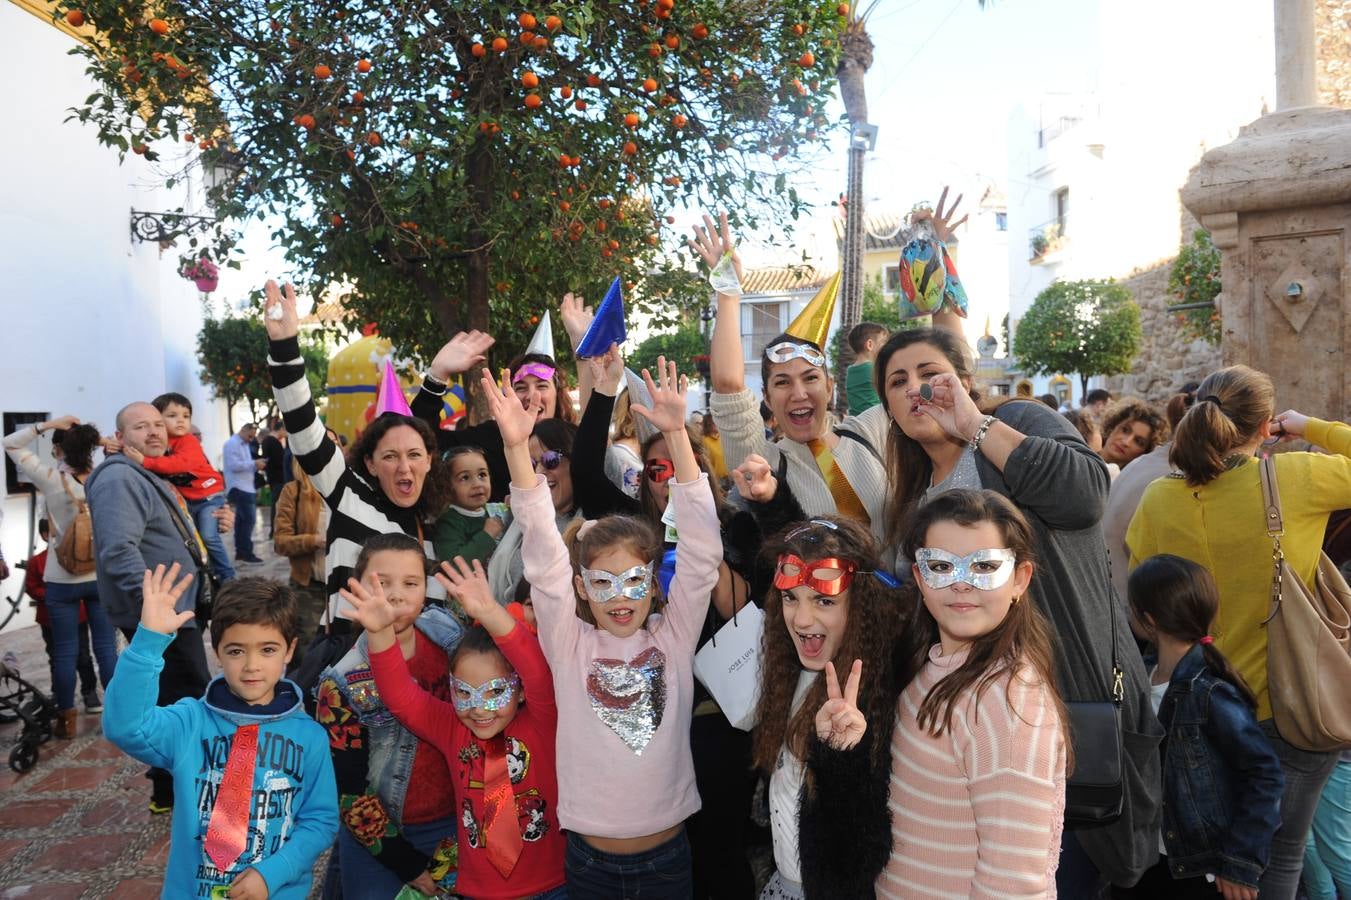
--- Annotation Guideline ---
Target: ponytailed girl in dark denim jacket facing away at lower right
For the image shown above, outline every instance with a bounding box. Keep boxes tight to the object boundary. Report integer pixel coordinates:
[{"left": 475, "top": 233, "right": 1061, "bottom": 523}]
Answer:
[{"left": 1112, "top": 554, "right": 1285, "bottom": 900}]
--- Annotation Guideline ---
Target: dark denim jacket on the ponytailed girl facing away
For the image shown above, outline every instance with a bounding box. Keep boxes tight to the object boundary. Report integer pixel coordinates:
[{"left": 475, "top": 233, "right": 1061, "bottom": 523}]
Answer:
[{"left": 1159, "top": 645, "right": 1285, "bottom": 888}]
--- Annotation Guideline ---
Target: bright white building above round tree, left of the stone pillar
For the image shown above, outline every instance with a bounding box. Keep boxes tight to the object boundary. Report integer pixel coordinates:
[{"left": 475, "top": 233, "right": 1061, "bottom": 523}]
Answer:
[{"left": 1008, "top": 0, "right": 1275, "bottom": 393}]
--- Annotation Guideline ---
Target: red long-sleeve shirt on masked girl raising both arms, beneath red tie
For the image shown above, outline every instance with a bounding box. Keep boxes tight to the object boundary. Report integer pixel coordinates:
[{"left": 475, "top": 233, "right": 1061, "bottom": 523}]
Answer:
[{"left": 370, "top": 623, "right": 565, "bottom": 900}]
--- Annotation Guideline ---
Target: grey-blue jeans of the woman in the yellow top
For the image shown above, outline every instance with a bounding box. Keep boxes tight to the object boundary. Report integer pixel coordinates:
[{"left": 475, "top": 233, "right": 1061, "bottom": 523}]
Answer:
[{"left": 1258, "top": 719, "right": 1340, "bottom": 900}]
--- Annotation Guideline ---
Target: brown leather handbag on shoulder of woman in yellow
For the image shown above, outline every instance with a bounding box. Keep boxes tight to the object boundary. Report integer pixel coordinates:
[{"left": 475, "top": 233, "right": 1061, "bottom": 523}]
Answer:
[{"left": 1262, "top": 457, "right": 1351, "bottom": 753}]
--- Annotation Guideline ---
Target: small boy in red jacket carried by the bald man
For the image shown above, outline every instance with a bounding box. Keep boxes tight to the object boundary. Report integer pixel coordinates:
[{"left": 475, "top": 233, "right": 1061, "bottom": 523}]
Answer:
[{"left": 146, "top": 392, "right": 235, "bottom": 581}]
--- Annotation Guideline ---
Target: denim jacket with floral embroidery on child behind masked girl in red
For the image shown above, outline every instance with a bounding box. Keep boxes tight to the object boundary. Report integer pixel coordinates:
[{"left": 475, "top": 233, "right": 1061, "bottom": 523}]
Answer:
[{"left": 319, "top": 607, "right": 463, "bottom": 822}]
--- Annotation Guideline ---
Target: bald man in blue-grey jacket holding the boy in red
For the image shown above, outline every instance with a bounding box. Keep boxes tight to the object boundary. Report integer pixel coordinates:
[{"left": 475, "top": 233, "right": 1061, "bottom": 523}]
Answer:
[{"left": 85, "top": 403, "right": 234, "bottom": 814}]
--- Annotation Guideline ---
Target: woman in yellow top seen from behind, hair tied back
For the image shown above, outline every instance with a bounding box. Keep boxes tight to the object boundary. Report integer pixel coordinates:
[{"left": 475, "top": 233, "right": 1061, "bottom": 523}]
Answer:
[{"left": 1125, "top": 366, "right": 1351, "bottom": 900}]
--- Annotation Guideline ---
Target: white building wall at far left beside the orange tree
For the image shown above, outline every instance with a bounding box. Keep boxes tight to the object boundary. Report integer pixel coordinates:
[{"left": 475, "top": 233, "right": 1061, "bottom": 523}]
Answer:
[{"left": 0, "top": 3, "right": 228, "bottom": 630}]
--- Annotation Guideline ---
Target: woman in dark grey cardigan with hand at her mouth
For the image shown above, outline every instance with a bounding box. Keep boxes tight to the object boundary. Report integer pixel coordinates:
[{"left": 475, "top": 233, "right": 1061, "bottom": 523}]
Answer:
[{"left": 874, "top": 328, "right": 1163, "bottom": 897}]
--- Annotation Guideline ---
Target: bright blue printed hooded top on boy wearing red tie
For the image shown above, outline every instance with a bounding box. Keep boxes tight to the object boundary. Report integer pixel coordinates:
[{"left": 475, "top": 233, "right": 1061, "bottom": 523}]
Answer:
[{"left": 103, "top": 627, "right": 338, "bottom": 900}]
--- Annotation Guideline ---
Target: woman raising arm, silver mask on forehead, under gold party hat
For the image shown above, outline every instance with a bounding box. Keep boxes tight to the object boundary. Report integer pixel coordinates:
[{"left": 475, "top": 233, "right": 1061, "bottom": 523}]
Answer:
[{"left": 689, "top": 214, "right": 886, "bottom": 536}]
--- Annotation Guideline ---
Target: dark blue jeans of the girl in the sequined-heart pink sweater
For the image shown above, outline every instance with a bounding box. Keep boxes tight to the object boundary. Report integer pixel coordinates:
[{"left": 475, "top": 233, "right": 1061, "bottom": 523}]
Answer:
[{"left": 563, "top": 828, "right": 694, "bottom": 900}]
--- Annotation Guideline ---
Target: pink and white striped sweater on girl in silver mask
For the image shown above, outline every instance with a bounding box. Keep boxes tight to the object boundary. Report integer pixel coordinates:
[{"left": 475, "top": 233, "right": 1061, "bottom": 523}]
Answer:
[{"left": 877, "top": 646, "right": 1066, "bottom": 900}]
